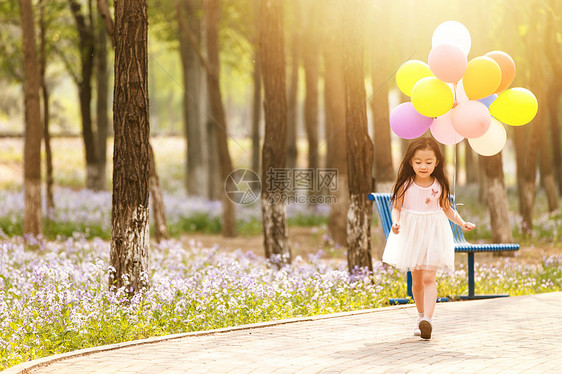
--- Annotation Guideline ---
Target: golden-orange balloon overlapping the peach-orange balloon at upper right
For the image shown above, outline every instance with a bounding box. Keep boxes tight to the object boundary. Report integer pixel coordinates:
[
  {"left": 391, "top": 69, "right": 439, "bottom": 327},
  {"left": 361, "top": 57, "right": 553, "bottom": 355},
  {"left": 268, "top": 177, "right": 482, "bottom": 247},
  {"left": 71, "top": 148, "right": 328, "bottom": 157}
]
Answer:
[{"left": 462, "top": 57, "right": 502, "bottom": 100}]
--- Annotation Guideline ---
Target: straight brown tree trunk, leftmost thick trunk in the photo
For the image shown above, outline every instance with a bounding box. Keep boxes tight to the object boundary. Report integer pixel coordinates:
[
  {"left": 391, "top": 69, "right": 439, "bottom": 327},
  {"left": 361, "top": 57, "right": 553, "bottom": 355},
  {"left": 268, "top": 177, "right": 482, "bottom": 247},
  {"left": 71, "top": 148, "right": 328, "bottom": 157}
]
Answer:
[{"left": 20, "top": 0, "right": 43, "bottom": 236}]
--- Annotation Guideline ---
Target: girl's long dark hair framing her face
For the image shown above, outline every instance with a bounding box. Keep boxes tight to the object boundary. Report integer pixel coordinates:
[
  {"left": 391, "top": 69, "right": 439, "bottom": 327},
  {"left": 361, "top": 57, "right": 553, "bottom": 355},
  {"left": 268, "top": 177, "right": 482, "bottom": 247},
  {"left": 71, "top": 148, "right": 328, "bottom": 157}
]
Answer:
[{"left": 392, "top": 137, "right": 451, "bottom": 207}]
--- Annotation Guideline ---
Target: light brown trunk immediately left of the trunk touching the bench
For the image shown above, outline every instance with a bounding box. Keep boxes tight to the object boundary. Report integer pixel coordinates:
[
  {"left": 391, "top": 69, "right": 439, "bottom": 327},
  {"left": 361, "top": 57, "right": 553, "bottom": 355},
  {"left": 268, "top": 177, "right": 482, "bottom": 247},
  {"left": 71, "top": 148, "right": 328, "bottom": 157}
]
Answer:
[{"left": 322, "top": 0, "right": 349, "bottom": 248}]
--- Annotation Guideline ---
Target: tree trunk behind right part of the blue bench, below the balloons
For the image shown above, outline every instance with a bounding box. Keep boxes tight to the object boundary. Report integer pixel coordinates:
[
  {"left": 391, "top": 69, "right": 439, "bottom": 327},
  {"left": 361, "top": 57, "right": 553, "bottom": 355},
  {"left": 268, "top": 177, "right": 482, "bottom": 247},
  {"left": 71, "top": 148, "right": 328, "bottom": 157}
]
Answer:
[{"left": 479, "top": 152, "right": 513, "bottom": 247}]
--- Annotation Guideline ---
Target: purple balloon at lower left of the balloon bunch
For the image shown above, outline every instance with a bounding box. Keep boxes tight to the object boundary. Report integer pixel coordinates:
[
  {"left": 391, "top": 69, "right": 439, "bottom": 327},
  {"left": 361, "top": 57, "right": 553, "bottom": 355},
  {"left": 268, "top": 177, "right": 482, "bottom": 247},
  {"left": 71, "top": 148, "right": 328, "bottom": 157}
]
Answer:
[{"left": 390, "top": 102, "right": 433, "bottom": 139}]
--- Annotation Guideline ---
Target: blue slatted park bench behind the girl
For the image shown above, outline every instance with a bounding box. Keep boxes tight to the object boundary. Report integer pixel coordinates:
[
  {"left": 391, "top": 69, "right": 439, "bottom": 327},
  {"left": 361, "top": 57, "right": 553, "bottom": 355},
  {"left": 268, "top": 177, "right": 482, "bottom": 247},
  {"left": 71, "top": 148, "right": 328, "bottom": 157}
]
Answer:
[{"left": 369, "top": 193, "right": 519, "bottom": 304}]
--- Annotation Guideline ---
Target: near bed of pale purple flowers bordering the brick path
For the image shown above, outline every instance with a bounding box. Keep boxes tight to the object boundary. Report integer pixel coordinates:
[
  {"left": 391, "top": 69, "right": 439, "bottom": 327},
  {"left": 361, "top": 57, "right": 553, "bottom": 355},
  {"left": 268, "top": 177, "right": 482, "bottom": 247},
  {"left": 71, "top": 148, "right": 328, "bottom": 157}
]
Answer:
[{"left": 0, "top": 235, "right": 562, "bottom": 369}]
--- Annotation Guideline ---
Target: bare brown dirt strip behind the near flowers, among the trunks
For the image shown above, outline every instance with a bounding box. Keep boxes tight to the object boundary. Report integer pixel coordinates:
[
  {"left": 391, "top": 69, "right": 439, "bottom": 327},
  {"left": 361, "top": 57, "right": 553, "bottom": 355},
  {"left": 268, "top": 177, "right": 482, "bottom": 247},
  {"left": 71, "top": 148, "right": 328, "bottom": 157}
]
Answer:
[{"left": 182, "top": 227, "right": 562, "bottom": 265}]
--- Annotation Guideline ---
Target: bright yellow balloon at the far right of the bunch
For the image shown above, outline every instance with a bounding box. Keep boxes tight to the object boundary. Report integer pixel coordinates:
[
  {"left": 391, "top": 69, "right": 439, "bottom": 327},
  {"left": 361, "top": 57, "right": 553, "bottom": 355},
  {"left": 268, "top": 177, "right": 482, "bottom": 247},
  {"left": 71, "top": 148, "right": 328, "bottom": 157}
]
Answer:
[{"left": 490, "top": 87, "right": 539, "bottom": 126}]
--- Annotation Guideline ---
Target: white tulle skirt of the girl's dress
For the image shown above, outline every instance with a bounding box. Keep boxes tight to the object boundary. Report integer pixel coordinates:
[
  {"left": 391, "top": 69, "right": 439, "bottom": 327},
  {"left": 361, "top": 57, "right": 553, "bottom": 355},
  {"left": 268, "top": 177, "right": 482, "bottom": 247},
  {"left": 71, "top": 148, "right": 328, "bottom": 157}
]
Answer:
[{"left": 382, "top": 209, "right": 455, "bottom": 271}]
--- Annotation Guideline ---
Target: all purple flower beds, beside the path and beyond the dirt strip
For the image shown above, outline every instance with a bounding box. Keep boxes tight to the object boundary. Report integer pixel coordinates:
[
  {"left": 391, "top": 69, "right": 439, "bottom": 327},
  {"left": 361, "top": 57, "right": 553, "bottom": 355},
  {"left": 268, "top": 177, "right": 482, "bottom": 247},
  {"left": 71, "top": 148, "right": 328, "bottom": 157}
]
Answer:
[{"left": 0, "top": 188, "right": 562, "bottom": 370}]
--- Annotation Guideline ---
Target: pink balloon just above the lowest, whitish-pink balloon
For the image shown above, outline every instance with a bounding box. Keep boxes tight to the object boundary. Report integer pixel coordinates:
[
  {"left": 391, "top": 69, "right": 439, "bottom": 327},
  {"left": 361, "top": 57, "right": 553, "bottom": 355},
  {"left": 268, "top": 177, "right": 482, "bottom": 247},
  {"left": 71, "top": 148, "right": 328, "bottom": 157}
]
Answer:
[{"left": 452, "top": 100, "right": 492, "bottom": 138}]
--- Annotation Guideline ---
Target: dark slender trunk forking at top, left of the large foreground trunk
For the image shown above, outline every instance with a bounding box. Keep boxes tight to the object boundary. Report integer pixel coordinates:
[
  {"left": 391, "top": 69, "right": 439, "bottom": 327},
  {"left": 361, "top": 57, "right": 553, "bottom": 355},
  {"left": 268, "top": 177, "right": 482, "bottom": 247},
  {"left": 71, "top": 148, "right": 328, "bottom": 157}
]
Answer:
[{"left": 68, "top": 0, "right": 100, "bottom": 190}]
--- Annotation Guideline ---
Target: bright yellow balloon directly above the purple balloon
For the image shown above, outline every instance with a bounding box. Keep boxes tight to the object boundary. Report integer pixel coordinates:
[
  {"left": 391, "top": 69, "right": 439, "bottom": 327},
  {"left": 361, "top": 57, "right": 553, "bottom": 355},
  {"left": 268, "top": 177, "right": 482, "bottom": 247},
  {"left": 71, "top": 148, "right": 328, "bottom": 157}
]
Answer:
[{"left": 412, "top": 77, "right": 454, "bottom": 117}]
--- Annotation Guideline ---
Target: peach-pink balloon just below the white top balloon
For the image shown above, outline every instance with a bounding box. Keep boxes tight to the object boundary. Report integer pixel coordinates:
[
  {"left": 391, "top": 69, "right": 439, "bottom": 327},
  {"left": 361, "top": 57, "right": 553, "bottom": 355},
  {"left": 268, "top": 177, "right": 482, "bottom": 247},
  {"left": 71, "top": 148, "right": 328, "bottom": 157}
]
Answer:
[{"left": 427, "top": 43, "right": 467, "bottom": 83}]
